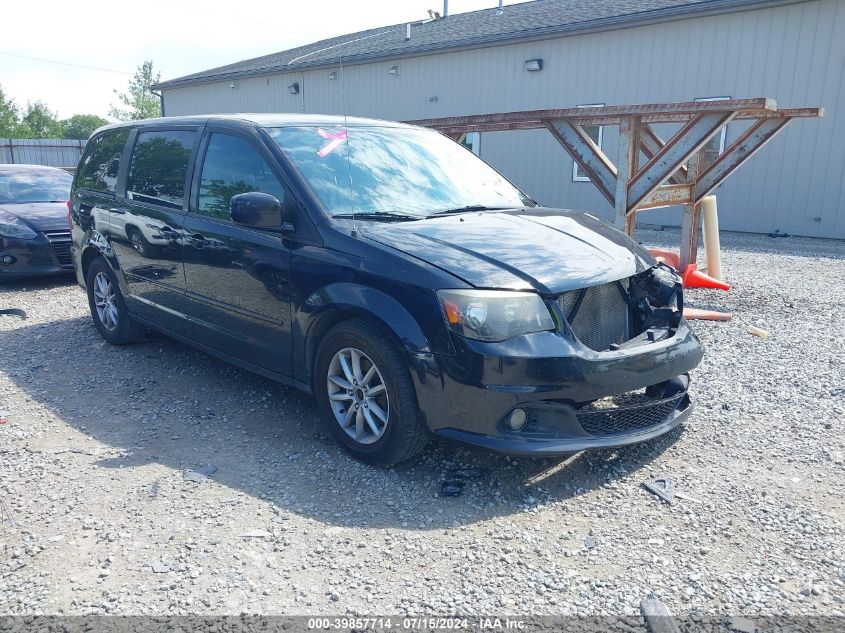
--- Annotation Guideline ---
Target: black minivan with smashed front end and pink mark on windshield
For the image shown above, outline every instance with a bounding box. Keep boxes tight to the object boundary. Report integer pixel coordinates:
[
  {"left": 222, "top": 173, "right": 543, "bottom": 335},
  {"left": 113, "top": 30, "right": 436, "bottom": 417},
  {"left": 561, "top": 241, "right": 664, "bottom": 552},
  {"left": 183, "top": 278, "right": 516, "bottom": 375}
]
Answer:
[{"left": 69, "top": 114, "right": 703, "bottom": 464}]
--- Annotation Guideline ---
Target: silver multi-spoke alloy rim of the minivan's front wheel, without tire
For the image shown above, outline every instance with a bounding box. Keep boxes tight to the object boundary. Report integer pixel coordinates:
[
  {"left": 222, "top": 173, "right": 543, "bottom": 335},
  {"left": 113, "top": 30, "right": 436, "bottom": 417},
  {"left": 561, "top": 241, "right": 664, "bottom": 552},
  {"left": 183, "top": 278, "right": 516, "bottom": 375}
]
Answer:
[{"left": 327, "top": 347, "right": 390, "bottom": 444}]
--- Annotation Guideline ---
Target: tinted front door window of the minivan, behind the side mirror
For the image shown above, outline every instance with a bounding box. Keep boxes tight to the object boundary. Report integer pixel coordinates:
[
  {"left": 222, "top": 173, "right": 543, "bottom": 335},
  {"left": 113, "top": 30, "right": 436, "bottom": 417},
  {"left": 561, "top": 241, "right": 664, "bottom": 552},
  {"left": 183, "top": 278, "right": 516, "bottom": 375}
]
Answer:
[{"left": 198, "top": 134, "right": 285, "bottom": 219}]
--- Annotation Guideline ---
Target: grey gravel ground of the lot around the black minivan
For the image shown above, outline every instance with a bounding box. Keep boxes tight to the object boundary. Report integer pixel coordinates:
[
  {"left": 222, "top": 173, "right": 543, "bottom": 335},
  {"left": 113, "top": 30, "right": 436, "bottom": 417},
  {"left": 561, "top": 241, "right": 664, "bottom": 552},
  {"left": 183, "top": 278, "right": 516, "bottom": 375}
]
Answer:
[{"left": 0, "top": 231, "right": 845, "bottom": 615}]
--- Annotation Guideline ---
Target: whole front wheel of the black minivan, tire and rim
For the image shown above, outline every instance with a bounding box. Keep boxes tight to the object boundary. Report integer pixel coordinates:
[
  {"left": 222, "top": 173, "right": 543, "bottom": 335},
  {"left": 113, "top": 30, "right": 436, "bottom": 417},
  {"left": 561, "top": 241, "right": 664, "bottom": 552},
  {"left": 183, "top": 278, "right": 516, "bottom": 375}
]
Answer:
[{"left": 314, "top": 319, "right": 428, "bottom": 466}]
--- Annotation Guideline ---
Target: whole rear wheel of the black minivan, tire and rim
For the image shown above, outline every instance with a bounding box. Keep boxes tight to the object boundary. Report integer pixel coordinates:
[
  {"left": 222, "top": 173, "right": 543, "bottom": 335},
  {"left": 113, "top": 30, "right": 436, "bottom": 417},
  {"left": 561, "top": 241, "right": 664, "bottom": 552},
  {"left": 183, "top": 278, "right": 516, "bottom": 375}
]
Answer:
[{"left": 85, "top": 257, "right": 146, "bottom": 345}]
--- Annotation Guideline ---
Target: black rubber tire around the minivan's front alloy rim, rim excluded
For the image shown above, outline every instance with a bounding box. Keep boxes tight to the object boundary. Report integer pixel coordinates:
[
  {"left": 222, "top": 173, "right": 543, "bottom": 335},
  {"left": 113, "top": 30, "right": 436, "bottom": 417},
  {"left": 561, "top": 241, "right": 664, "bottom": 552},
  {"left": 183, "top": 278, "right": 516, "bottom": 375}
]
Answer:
[{"left": 314, "top": 319, "right": 428, "bottom": 466}]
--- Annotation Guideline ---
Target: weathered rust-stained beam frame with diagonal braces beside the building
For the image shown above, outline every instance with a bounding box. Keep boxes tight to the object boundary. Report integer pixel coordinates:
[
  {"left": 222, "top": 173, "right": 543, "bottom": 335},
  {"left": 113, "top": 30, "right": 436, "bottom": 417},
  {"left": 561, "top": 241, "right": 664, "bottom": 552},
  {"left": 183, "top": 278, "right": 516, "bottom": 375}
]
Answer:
[{"left": 407, "top": 98, "right": 824, "bottom": 268}]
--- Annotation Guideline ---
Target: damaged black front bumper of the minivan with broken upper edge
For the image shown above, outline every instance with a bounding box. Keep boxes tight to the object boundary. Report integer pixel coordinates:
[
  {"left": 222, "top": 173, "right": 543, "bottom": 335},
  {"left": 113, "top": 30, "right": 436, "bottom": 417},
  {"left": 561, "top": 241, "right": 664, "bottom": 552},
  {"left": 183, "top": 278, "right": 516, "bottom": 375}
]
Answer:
[{"left": 412, "top": 264, "right": 704, "bottom": 455}]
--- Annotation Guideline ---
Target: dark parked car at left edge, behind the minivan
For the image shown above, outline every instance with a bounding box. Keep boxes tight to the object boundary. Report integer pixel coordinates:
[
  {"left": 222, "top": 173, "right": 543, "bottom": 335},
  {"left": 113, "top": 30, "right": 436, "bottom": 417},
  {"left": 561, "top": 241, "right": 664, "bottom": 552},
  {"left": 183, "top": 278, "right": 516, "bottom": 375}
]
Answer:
[{"left": 0, "top": 165, "right": 73, "bottom": 279}]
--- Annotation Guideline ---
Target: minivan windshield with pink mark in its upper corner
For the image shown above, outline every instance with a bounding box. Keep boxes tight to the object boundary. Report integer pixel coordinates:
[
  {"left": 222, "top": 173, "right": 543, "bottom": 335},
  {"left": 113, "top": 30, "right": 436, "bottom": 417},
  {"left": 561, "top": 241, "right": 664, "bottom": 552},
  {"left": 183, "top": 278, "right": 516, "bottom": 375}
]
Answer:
[{"left": 267, "top": 126, "right": 535, "bottom": 217}]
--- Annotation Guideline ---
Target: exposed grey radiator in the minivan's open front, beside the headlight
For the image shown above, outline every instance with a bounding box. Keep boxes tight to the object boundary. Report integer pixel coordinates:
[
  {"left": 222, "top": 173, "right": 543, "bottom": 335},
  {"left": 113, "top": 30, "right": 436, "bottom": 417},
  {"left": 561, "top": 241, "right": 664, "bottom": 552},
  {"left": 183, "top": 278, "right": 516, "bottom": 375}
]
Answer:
[{"left": 557, "top": 279, "right": 630, "bottom": 352}]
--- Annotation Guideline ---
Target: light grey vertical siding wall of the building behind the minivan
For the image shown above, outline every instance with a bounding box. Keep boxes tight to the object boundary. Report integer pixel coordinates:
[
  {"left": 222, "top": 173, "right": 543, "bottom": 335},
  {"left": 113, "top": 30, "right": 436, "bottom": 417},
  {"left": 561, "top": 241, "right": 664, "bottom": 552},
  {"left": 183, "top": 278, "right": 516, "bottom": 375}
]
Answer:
[{"left": 165, "top": 0, "right": 845, "bottom": 238}]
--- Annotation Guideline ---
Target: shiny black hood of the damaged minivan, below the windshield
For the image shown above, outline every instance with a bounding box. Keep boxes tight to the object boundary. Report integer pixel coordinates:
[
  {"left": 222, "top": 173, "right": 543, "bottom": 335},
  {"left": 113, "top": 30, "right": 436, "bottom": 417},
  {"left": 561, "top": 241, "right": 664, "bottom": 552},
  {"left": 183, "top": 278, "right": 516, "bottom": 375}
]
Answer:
[{"left": 360, "top": 209, "right": 655, "bottom": 294}]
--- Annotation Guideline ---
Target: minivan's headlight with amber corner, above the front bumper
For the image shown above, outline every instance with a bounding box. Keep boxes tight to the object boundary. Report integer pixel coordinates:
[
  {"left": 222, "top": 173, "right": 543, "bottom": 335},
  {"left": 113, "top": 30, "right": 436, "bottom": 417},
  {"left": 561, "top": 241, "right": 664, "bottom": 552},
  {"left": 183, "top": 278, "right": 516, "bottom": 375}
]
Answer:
[{"left": 437, "top": 290, "right": 555, "bottom": 341}]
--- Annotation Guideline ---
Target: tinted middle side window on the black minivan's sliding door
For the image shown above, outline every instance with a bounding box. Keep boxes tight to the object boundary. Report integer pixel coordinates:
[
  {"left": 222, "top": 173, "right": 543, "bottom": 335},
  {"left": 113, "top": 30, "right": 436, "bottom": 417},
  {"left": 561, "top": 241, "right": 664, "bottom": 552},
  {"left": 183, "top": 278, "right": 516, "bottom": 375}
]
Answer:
[{"left": 126, "top": 130, "right": 196, "bottom": 209}]
